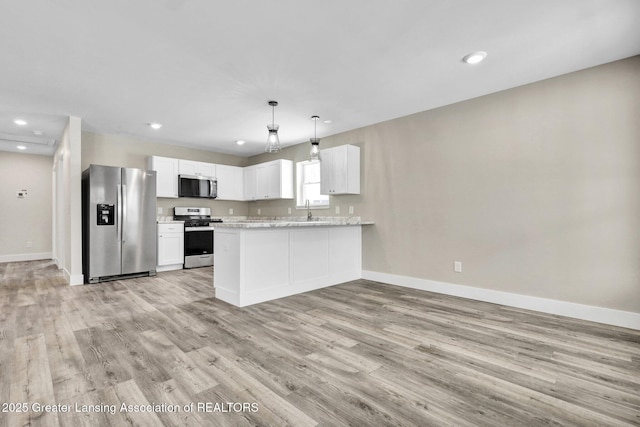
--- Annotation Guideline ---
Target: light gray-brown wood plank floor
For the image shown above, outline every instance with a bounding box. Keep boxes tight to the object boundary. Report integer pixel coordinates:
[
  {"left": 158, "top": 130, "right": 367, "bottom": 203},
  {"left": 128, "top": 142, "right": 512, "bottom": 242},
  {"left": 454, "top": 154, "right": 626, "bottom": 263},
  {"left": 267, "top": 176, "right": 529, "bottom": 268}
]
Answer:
[{"left": 0, "top": 261, "right": 640, "bottom": 427}]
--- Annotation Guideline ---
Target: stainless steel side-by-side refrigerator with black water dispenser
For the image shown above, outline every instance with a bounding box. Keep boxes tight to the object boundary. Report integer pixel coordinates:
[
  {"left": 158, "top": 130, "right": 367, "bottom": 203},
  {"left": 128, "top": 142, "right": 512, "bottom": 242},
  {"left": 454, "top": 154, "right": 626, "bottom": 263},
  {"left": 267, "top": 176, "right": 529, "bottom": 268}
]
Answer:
[{"left": 82, "top": 165, "right": 157, "bottom": 283}]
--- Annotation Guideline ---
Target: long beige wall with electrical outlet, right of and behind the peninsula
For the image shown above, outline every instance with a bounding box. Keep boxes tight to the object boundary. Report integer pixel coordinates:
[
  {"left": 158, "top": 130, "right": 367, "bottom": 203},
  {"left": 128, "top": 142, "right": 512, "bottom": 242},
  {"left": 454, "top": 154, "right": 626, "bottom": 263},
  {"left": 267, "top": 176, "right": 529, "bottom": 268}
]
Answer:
[{"left": 249, "top": 57, "right": 640, "bottom": 312}]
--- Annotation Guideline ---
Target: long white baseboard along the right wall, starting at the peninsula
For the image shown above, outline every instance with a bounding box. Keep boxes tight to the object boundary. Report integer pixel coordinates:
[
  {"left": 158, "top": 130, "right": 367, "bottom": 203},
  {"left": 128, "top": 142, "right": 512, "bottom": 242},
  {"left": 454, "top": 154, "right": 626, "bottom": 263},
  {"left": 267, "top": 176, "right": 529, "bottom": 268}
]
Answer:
[{"left": 362, "top": 270, "right": 640, "bottom": 330}]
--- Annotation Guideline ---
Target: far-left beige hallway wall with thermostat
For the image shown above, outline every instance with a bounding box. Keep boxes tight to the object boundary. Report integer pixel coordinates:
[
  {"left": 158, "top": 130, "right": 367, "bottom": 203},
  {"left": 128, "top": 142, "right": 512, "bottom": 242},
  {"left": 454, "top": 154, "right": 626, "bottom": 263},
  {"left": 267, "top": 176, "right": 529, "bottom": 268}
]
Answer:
[{"left": 0, "top": 151, "right": 53, "bottom": 262}]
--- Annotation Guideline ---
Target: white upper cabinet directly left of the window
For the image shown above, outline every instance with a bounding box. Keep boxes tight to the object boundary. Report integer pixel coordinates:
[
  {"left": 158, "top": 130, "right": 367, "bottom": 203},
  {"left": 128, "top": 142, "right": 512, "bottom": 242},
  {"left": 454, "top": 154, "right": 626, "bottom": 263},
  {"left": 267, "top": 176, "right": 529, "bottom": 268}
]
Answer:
[{"left": 244, "top": 159, "right": 293, "bottom": 200}]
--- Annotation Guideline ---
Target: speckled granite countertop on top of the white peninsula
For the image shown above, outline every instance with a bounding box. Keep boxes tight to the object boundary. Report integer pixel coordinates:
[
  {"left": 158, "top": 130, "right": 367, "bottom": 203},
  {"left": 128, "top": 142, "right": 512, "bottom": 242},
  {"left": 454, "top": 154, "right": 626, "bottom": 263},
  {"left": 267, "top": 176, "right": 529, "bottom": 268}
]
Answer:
[{"left": 215, "top": 216, "right": 374, "bottom": 228}]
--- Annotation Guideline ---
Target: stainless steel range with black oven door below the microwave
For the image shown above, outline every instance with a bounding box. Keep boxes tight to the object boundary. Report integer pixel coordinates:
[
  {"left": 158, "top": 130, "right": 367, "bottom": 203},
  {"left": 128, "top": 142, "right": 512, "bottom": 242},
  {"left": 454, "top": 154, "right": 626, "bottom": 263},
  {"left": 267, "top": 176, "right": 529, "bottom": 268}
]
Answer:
[{"left": 173, "top": 207, "right": 222, "bottom": 268}]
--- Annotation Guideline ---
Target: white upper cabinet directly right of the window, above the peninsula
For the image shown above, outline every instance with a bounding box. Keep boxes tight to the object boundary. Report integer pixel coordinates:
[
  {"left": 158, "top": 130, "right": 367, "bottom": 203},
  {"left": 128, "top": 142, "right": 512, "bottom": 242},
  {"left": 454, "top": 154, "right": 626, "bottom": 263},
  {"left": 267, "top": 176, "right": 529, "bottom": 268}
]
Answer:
[{"left": 320, "top": 145, "right": 360, "bottom": 195}]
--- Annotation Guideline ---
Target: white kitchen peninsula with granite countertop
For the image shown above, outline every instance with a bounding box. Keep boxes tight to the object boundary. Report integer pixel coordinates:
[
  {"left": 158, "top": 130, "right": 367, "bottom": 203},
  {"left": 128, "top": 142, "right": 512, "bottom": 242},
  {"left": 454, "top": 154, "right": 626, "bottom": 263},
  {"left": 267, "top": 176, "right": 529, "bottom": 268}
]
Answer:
[{"left": 213, "top": 217, "right": 373, "bottom": 307}]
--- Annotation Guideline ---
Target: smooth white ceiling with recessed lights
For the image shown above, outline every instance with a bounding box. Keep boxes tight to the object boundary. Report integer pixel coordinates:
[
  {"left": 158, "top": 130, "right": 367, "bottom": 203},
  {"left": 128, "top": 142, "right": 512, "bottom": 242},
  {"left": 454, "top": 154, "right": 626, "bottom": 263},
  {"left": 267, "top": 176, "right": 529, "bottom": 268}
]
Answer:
[{"left": 0, "top": 0, "right": 640, "bottom": 156}]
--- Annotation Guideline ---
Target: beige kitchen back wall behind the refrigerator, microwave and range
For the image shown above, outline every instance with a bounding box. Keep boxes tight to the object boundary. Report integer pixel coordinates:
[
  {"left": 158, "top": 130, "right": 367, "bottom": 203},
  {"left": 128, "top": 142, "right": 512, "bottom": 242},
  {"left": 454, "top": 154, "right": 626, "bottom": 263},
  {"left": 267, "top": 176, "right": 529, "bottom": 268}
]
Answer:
[{"left": 82, "top": 132, "right": 248, "bottom": 216}]
